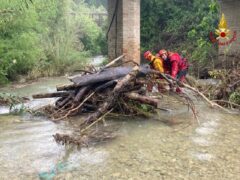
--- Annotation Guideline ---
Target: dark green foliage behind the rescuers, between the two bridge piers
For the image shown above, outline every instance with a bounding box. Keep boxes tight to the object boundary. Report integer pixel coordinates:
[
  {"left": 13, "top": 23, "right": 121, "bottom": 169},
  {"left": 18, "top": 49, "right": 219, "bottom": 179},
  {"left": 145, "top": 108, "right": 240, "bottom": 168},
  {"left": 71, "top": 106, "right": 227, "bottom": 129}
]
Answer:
[{"left": 141, "top": 0, "right": 219, "bottom": 75}]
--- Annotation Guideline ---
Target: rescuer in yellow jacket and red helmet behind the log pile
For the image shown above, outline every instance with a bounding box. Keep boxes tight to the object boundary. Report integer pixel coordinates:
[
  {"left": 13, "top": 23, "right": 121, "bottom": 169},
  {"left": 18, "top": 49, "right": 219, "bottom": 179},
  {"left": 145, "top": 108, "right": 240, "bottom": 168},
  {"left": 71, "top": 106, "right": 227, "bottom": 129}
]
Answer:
[{"left": 144, "top": 51, "right": 165, "bottom": 92}]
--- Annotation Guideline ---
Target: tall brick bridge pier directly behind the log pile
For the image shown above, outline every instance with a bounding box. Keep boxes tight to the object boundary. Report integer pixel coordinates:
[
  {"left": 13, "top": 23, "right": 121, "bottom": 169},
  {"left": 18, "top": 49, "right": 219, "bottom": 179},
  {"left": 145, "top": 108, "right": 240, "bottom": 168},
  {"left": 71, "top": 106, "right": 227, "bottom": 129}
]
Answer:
[{"left": 108, "top": 0, "right": 140, "bottom": 64}]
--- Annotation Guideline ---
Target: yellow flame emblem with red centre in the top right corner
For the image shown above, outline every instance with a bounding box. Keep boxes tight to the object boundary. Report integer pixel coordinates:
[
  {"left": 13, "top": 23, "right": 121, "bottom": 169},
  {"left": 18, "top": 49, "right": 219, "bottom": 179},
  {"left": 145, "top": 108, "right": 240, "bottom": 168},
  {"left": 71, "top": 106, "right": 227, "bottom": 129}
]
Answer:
[{"left": 215, "top": 14, "right": 230, "bottom": 40}]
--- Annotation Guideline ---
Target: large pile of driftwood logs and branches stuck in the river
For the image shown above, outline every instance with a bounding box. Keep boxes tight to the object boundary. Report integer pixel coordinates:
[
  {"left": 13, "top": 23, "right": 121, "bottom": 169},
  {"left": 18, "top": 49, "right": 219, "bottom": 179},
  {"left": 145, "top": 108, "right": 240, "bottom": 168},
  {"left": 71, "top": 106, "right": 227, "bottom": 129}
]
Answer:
[{"left": 33, "top": 56, "right": 234, "bottom": 145}]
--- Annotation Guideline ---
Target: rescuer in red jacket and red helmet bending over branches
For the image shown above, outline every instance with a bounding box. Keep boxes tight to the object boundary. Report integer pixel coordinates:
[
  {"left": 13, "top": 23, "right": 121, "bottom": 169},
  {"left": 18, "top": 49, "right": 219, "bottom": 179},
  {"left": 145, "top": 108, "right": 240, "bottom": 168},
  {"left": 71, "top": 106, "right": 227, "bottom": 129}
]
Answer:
[{"left": 158, "top": 49, "right": 189, "bottom": 92}]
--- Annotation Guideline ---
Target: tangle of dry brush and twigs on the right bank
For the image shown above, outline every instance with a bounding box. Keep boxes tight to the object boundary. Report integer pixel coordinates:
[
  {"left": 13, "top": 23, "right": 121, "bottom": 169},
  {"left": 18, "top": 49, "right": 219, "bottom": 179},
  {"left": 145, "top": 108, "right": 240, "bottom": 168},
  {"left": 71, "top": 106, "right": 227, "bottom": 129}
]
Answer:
[{"left": 188, "top": 68, "right": 240, "bottom": 109}]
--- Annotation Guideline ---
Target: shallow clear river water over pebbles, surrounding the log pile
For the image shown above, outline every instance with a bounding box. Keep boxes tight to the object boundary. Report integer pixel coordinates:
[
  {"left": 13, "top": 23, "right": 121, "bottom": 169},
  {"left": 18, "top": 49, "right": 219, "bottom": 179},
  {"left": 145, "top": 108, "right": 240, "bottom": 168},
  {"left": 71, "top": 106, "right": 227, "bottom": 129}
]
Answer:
[{"left": 0, "top": 78, "right": 240, "bottom": 180}]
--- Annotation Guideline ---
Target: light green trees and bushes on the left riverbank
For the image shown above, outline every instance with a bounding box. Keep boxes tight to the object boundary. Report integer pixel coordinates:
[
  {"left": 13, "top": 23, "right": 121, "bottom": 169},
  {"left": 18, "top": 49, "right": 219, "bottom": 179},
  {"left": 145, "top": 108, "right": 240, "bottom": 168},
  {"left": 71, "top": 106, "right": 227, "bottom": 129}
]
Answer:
[{"left": 0, "top": 0, "right": 106, "bottom": 84}]
